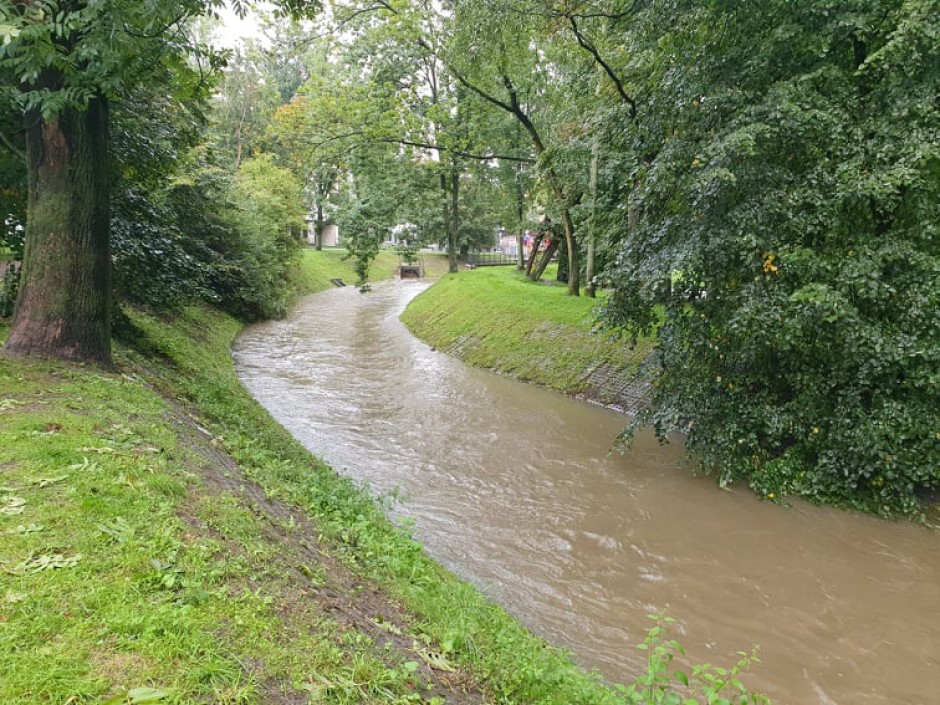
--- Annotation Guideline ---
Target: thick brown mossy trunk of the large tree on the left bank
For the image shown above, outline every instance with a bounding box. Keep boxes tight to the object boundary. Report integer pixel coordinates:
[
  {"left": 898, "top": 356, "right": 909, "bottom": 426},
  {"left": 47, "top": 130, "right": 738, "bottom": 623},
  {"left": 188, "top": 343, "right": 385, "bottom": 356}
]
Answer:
[{"left": 3, "top": 98, "right": 111, "bottom": 367}]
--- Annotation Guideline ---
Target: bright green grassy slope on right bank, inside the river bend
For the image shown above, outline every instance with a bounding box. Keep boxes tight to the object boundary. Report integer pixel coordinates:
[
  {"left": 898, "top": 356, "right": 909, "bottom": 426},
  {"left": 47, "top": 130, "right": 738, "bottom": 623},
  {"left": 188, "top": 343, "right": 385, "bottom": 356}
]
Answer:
[{"left": 402, "top": 267, "right": 652, "bottom": 411}]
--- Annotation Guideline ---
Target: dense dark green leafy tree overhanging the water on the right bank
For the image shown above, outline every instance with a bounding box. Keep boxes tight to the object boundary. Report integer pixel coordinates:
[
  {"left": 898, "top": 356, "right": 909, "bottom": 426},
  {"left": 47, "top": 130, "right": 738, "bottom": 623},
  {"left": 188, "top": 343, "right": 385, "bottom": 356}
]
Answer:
[{"left": 606, "top": 0, "right": 940, "bottom": 514}]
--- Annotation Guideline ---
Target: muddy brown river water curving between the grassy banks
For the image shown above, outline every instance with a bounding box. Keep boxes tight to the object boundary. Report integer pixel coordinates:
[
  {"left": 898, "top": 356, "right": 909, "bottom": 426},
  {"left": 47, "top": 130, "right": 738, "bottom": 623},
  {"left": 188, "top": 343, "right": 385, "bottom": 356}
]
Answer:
[{"left": 234, "top": 282, "right": 940, "bottom": 705}]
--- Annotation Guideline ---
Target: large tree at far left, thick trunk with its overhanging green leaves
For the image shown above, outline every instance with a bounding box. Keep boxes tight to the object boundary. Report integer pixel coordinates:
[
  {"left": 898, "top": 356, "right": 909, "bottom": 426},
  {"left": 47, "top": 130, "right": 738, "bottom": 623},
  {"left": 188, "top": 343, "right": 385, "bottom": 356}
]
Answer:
[{"left": 0, "top": 0, "right": 318, "bottom": 365}]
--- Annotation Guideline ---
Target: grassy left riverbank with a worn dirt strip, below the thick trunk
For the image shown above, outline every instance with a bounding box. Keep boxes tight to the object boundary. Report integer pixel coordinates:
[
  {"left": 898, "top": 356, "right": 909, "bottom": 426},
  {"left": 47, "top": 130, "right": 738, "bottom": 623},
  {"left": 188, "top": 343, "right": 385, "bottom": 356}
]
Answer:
[{"left": 0, "top": 246, "right": 632, "bottom": 705}]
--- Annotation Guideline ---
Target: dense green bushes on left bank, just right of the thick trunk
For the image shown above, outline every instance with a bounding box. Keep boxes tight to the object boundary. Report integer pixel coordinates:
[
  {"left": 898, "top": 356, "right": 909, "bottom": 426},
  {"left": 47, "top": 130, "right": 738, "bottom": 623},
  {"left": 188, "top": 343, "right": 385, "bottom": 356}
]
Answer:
[{"left": 111, "top": 84, "right": 304, "bottom": 318}]
